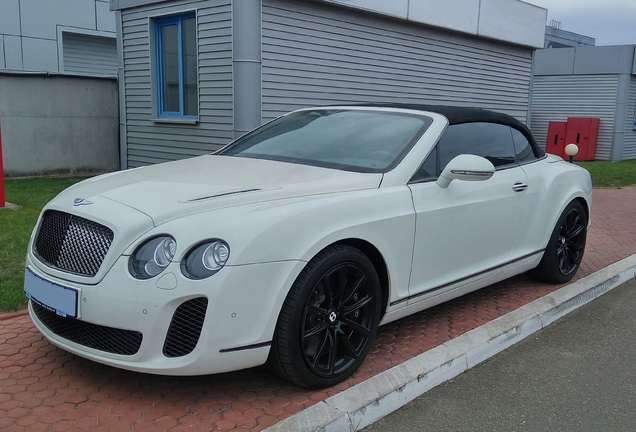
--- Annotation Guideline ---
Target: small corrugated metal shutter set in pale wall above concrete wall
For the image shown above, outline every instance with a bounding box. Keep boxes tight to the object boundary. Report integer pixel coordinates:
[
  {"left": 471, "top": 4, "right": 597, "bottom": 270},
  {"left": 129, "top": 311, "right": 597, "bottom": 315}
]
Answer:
[{"left": 62, "top": 32, "right": 117, "bottom": 76}]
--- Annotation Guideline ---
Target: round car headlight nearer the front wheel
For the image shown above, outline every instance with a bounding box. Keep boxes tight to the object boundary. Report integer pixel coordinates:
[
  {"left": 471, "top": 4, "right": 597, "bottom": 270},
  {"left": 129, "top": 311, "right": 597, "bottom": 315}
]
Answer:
[{"left": 181, "top": 239, "right": 230, "bottom": 279}]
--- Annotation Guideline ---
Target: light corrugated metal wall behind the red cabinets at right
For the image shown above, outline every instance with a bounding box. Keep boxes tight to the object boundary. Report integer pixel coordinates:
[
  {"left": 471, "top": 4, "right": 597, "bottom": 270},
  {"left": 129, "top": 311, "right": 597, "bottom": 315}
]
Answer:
[{"left": 531, "top": 75, "right": 620, "bottom": 160}]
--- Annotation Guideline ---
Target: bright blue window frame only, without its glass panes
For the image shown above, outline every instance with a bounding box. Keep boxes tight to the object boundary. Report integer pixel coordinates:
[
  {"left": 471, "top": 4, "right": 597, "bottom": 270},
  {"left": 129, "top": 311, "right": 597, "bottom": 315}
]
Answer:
[{"left": 151, "top": 10, "right": 200, "bottom": 123}]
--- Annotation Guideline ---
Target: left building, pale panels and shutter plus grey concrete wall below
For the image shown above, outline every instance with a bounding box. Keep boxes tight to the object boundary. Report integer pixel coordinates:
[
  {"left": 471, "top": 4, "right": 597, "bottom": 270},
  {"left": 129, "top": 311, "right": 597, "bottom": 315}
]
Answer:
[{"left": 0, "top": 0, "right": 119, "bottom": 176}]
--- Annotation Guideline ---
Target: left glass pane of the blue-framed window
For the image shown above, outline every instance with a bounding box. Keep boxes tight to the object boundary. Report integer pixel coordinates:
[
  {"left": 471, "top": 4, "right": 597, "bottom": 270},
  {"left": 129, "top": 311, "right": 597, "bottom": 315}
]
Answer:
[{"left": 161, "top": 24, "right": 180, "bottom": 112}]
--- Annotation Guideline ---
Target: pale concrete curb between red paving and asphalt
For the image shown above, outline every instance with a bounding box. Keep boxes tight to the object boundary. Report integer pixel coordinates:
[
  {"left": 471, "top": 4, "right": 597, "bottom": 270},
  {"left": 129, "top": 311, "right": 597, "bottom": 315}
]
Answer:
[{"left": 266, "top": 254, "right": 636, "bottom": 432}]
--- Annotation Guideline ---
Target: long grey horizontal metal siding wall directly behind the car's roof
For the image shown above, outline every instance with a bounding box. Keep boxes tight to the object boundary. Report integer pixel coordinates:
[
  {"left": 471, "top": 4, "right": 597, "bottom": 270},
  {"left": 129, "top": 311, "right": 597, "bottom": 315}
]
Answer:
[{"left": 262, "top": 0, "right": 532, "bottom": 121}]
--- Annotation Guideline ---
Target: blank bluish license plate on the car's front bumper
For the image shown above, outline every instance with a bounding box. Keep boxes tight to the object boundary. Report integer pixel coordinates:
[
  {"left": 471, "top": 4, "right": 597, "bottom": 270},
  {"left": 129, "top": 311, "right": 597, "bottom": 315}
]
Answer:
[{"left": 24, "top": 268, "right": 79, "bottom": 318}]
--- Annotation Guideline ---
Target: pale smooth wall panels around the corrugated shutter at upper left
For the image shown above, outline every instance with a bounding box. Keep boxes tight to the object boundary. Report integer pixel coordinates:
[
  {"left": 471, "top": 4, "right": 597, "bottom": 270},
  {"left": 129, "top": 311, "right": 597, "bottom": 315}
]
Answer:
[{"left": 0, "top": 0, "right": 115, "bottom": 72}]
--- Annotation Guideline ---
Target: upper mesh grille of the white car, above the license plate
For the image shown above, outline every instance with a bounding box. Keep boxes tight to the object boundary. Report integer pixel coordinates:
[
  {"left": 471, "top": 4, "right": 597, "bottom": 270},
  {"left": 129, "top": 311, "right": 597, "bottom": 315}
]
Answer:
[{"left": 35, "top": 210, "right": 114, "bottom": 276}]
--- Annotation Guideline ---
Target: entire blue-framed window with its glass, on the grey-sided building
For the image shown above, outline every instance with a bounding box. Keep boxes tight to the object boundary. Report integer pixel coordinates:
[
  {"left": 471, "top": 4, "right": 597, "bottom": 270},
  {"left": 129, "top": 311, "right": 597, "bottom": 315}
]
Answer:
[{"left": 155, "top": 13, "right": 199, "bottom": 118}]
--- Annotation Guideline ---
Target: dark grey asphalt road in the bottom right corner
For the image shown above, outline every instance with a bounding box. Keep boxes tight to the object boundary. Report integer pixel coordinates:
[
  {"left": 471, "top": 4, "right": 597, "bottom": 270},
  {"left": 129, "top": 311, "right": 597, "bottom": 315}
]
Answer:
[{"left": 364, "top": 279, "right": 636, "bottom": 432}]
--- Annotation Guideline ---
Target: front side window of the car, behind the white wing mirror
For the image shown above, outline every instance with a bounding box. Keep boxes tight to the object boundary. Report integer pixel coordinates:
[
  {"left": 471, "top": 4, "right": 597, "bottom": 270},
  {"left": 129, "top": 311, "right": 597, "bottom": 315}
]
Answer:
[{"left": 437, "top": 122, "right": 515, "bottom": 171}]
